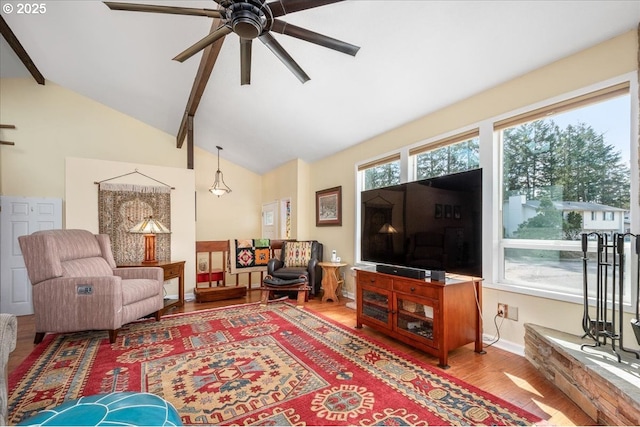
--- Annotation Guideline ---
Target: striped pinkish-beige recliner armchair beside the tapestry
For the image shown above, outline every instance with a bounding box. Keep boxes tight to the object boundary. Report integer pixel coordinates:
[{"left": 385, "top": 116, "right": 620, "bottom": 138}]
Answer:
[{"left": 18, "top": 230, "right": 164, "bottom": 344}]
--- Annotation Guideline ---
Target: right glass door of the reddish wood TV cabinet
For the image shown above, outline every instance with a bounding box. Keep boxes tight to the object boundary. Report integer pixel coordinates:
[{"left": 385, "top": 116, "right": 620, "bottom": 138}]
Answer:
[{"left": 395, "top": 294, "right": 439, "bottom": 348}]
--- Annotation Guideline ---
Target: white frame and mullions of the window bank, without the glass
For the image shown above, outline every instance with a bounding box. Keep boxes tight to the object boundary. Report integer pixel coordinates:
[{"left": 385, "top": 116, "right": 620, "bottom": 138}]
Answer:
[{"left": 354, "top": 72, "right": 640, "bottom": 312}]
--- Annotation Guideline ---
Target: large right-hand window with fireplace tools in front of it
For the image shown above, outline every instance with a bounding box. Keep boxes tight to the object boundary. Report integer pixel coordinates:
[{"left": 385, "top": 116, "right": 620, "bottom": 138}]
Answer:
[{"left": 494, "top": 83, "right": 631, "bottom": 298}]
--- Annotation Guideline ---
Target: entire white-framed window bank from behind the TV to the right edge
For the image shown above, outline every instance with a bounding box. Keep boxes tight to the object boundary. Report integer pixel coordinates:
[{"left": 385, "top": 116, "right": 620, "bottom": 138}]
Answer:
[{"left": 356, "top": 74, "right": 639, "bottom": 310}]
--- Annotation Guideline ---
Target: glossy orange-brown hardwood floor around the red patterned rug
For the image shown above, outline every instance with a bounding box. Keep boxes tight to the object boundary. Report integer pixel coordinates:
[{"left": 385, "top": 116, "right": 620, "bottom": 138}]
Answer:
[{"left": 8, "top": 289, "right": 595, "bottom": 425}]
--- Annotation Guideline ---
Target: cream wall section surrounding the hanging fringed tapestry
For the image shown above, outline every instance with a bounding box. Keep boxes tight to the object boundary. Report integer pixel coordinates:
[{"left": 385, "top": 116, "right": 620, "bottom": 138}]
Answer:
[{"left": 64, "top": 157, "right": 196, "bottom": 295}]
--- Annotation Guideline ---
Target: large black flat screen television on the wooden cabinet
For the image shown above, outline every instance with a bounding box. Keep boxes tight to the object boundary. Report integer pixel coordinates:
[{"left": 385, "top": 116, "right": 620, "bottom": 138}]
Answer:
[{"left": 360, "top": 169, "right": 482, "bottom": 277}]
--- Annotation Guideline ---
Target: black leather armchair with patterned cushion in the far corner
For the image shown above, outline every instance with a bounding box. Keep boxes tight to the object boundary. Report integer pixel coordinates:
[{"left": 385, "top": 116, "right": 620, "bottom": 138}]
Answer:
[{"left": 267, "top": 240, "right": 322, "bottom": 296}]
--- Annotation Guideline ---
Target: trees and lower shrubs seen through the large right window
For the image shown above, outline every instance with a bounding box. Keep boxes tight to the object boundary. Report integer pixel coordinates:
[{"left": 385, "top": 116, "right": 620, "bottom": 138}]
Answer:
[{"left": 503, "top": 113, "right": 631, "bottom": 240}]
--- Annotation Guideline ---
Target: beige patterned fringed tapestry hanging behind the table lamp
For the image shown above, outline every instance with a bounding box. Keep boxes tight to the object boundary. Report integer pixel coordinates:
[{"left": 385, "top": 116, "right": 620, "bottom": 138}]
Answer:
[{"left": 98, "top": 183, "right": 171, "bottom": 265}]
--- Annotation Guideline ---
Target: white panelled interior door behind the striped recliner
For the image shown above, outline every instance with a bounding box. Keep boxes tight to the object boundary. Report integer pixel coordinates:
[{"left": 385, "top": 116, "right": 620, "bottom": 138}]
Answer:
[{"left": 0, "top": 196, "right": 62, "bottom": 316}]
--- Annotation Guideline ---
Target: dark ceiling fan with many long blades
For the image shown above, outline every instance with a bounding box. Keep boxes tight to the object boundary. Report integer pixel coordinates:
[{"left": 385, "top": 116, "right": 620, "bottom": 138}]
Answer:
[{"left": 104, "top": 0, "right": 360, "bottom": 85}]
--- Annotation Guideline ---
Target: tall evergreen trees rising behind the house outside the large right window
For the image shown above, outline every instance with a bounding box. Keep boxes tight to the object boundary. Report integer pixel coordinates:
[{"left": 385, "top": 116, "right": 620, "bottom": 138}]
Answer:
[{"left": 503, "top": 119, "right": 630, "bottom": 209}]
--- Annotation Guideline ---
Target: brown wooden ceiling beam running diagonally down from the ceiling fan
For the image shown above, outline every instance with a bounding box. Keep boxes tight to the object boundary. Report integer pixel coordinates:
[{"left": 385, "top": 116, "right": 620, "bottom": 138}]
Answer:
[{"left": 176, "top": 18, "right": 225, "bottom": 150}]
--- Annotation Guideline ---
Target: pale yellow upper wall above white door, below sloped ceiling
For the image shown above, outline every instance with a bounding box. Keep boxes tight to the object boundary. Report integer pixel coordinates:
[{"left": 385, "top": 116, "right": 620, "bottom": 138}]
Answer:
[{"left": 0, "top": 78, "right": 186, "bottom": 198}]
